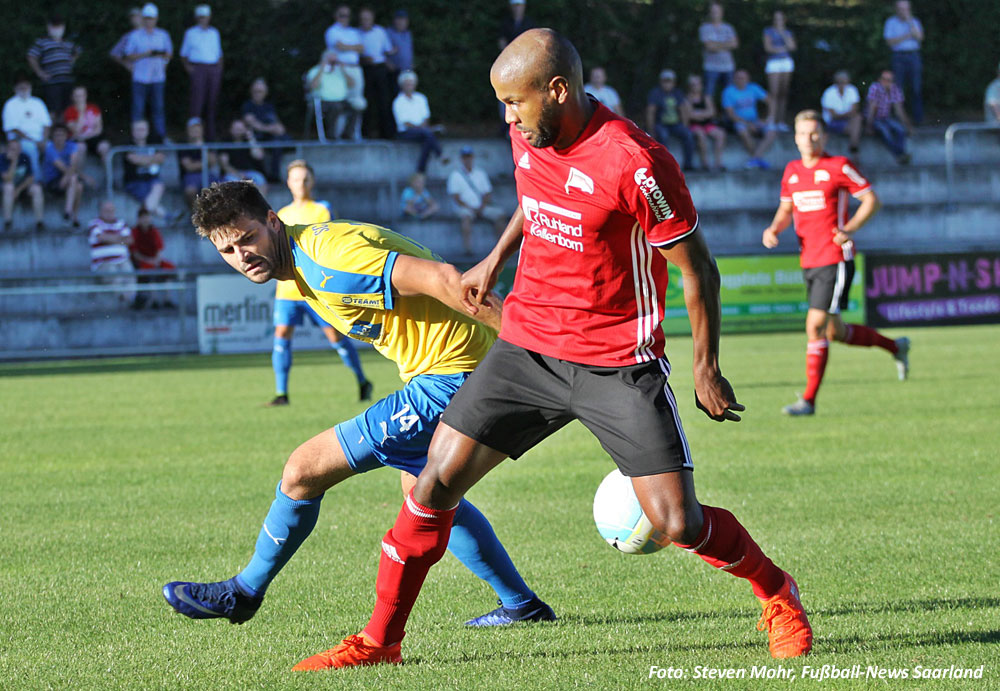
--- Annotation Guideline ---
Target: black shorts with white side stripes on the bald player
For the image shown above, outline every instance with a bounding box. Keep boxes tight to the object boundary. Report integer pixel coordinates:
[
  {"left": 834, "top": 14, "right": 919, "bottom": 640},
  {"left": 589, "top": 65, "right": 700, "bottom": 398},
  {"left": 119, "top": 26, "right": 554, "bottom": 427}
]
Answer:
[{"left": 441, "top": 341, "right": 693, "bottom": 477}]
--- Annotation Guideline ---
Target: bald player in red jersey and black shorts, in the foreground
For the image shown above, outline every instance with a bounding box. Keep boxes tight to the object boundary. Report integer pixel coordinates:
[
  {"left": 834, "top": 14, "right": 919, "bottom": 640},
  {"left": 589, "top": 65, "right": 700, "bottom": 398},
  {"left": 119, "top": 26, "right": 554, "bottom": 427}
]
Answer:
[{"left": 296, "top": 29, "right": 812, "bottom": 670}]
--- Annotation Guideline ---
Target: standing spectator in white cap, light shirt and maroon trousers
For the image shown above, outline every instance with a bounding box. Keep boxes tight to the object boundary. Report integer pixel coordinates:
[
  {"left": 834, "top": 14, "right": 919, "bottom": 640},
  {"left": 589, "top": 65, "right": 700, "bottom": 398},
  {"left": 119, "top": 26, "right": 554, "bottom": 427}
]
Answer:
[{"left": 181, "top": 5, "right": 222, "bottom": 141}]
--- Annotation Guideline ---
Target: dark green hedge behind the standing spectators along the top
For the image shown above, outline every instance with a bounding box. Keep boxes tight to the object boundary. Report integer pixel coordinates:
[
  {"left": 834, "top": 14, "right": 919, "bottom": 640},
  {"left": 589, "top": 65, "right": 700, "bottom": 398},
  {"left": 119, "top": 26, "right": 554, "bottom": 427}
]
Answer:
[{"left": 0, "top": 0, "right": 1000, "bottom": 141}]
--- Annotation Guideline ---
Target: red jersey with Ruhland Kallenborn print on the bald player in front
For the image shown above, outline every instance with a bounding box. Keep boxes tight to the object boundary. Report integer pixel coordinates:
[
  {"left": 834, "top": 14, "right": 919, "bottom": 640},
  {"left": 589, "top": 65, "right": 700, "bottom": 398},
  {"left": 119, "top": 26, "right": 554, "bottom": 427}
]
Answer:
[{"left": 500, "top": 101, "right": 698, "bottom": 367}]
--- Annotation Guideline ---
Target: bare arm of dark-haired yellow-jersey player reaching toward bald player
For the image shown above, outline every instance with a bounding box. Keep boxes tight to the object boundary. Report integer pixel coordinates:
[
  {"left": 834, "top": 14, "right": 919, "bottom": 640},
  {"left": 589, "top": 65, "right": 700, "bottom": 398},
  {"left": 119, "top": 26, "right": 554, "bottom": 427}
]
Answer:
[{"left": 392, "top": 254, "right": 503, "bottom": 331}]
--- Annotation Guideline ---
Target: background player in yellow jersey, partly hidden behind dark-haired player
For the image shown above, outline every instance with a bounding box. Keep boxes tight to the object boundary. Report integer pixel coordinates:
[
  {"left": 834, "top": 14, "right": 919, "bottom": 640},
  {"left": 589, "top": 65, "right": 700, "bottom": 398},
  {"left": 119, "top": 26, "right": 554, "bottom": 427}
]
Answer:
[{"left": 268, "top": 158, "right": 372, "bottom": 406}]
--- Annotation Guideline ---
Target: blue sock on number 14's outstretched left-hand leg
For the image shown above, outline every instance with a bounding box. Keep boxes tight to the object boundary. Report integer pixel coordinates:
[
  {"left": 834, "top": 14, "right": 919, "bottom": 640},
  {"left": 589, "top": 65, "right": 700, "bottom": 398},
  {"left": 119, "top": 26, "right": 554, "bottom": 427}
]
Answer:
[{"left": 236, "top": 482, "right": 323, "bottom": 595}]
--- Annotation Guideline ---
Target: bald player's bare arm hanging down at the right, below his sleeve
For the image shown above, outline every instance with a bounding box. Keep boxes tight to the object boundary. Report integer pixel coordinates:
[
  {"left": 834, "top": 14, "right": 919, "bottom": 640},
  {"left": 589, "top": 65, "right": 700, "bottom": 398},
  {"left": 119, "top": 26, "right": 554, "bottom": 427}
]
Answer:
[{"left": 659, "top": 230, "right": 744, "bottom": 422}]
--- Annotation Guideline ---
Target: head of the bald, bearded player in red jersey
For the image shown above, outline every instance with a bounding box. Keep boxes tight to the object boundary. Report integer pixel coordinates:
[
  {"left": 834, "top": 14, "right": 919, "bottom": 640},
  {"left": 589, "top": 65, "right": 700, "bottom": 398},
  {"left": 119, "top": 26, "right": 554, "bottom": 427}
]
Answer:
[{"left": 490, "top": 29, "right": 590, "bottom": 148}]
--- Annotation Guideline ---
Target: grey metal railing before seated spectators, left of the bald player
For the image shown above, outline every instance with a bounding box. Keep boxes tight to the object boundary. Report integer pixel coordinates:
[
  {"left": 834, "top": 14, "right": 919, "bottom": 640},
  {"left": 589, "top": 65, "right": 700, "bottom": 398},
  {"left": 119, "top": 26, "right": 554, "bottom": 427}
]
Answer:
[{"left": 104, "top": 139, "right": 399, "bottom": 221}]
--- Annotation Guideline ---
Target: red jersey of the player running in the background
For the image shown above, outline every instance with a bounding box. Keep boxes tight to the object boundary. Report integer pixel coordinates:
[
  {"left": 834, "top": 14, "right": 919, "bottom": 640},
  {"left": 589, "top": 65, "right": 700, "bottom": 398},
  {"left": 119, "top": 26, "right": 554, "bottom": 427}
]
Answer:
[{"left": 781, "top": 155, "right": 872, "bottom": 269}]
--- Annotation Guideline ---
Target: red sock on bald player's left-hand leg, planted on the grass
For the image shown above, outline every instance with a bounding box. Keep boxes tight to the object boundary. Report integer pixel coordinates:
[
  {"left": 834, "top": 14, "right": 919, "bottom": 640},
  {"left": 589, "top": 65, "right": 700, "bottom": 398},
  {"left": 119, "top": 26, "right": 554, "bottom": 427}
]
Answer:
[{"left": 363, "top": 492, "right": 458, "bottom": 645}]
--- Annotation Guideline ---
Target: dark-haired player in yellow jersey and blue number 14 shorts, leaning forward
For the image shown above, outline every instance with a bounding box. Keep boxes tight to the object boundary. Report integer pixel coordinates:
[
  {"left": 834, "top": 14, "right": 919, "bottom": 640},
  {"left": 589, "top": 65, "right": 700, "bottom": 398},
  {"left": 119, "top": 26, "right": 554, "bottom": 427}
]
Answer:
[{"left": 163, "top": 182, "right": 555, "bottom": 656}]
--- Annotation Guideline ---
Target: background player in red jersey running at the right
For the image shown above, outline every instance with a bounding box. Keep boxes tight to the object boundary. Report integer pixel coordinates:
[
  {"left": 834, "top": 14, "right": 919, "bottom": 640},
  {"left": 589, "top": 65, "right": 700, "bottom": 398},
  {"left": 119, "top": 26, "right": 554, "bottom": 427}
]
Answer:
[{"left": 763, "top": 110, "right": 910, "bottom": 415}]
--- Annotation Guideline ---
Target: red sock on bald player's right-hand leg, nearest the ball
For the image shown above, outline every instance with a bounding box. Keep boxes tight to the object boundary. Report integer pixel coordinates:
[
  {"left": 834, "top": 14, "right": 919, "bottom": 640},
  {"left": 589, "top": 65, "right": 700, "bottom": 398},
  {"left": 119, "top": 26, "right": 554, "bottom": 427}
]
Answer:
[{"left": 674, "top": 505, "right": 785, "bottom": 600}]
